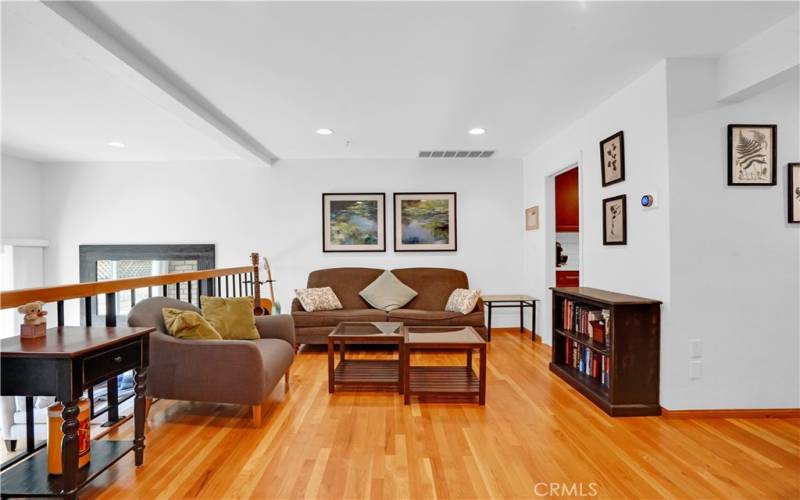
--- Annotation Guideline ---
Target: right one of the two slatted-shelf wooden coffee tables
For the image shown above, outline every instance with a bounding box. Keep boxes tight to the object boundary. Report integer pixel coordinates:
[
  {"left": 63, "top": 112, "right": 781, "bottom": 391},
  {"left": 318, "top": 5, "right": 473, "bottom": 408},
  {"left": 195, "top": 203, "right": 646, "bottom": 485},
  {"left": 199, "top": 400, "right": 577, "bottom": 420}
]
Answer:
[{"left": 401, "top": 326, "right": 486, "bottom": 405}]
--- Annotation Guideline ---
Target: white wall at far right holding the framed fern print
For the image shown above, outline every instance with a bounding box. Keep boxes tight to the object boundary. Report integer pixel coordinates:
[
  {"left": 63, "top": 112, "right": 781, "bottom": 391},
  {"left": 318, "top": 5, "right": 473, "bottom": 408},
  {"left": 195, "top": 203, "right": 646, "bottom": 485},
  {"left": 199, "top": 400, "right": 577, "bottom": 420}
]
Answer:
[{"left": 662, "top": 59, "right": 800, "bottom": 409}]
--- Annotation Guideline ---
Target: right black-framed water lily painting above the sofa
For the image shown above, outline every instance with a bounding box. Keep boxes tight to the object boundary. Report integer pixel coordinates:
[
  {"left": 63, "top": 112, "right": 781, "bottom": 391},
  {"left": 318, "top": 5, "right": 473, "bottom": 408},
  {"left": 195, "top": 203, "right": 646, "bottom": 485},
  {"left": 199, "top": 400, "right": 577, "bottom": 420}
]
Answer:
[{"left": 394, "top": 193, "right": 458, "bottom": 252}]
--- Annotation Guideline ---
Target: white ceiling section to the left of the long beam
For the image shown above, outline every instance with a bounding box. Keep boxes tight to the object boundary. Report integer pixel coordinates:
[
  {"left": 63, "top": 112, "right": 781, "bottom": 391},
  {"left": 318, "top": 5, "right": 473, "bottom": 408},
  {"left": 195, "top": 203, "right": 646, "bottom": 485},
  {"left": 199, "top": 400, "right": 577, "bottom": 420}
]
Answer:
[{"left": 2, "top": 2, "right": 241, "bottom": 162}]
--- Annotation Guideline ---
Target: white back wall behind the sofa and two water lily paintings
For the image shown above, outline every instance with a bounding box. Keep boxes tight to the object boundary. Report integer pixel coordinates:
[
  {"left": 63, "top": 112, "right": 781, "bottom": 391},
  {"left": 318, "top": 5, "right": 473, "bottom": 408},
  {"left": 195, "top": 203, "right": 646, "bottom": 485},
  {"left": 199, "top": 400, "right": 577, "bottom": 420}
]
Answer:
[{"left": 43, "top": 159, "right": 529, "bottom": 326}]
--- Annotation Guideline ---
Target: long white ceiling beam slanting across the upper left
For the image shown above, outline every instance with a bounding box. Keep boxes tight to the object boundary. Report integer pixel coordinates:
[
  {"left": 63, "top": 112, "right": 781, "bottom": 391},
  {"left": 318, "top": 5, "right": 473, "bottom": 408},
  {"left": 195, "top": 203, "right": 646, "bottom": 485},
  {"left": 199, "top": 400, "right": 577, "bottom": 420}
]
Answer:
[{"left": 37, "top": 1, "right": 278, "bottom": 166}]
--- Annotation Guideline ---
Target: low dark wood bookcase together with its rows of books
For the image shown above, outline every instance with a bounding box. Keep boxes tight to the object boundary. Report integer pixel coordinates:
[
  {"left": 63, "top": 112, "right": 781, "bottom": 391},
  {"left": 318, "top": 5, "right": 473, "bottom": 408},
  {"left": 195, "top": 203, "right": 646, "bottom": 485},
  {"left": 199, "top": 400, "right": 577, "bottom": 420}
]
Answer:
[{"left": 550, "top": 287, "right": 661, "bottom": 417}]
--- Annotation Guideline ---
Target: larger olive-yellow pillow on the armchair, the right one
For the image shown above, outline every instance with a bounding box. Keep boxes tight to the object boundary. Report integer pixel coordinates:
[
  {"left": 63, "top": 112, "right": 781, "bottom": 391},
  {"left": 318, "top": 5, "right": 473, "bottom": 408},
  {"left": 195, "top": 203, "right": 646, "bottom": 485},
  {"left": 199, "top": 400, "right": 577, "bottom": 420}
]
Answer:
[{"left": 200, "top": 296, "right": 260, "bottom": 340}]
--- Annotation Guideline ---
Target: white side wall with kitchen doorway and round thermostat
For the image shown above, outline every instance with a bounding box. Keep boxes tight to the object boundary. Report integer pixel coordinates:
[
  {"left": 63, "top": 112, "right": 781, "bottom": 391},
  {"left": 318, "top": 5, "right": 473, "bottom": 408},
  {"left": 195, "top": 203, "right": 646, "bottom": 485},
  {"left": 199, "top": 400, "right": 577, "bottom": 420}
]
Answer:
[{"left": 523, "top": 62, "right": 669, "bottom": 343}]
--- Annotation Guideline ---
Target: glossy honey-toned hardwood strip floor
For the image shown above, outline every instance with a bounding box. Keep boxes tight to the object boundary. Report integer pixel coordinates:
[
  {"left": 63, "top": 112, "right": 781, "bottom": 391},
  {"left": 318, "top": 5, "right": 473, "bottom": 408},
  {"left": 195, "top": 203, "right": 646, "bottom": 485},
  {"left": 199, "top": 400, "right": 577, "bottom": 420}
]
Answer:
[{"left": 81, "top": 329, "right": 800, "bottom": 499}]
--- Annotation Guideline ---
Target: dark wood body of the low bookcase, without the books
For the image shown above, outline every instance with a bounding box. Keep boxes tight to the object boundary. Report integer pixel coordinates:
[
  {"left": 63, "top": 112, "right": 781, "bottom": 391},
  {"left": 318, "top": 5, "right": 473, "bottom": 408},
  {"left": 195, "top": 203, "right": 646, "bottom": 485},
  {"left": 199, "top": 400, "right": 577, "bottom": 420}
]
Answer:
[{"left": 550, "top": 287, "right": 661, "bottom": 417}]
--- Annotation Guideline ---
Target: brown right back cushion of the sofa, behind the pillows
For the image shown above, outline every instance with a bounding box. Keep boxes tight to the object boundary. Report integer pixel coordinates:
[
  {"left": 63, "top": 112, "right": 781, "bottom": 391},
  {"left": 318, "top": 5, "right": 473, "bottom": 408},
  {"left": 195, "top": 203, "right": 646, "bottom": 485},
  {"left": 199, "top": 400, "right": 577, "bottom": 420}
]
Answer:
[{"left": 392, "top": 267, "right": 469, "bottom": 311}]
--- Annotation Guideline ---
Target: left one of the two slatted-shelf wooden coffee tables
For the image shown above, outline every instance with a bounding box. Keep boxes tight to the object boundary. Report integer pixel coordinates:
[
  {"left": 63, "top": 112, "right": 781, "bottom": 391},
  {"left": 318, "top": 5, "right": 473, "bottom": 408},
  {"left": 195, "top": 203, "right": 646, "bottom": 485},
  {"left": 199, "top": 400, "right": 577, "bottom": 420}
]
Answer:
[{"left": 328, "top": 322, "right": 404, "bottom": 394}]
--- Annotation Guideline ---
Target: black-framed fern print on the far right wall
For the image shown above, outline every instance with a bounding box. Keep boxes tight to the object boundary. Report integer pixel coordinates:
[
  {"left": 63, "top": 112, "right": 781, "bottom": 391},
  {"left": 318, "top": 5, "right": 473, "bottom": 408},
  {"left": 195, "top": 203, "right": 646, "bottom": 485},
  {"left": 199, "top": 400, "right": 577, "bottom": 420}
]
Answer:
[{"left": 728, "top": 125, "right": 778, "bottom": 186}]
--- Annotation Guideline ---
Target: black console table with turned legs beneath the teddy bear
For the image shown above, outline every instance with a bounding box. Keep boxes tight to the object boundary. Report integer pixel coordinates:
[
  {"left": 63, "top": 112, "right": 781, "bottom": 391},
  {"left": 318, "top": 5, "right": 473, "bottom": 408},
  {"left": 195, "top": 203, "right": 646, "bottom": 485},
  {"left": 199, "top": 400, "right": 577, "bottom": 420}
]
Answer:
[{"left": 0, "top": 326, "right": 154, "bottom": 498}]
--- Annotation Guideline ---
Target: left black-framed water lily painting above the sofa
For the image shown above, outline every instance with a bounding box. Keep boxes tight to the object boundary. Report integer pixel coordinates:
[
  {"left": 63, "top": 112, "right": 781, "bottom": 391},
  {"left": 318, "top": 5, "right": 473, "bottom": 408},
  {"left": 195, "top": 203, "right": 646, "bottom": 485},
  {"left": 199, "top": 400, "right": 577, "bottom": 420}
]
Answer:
[{"left": 322, "top": 193, "right": 386, "bottom": 252}]
